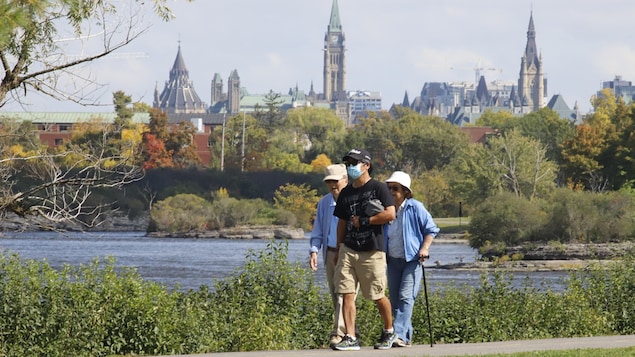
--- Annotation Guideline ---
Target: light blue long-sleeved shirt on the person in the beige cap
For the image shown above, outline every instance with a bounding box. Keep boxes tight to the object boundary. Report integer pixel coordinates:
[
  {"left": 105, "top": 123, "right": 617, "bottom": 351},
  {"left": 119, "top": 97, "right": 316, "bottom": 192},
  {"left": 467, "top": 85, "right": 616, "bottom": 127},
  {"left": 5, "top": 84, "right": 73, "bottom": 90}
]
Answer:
[{"left": 310, "top": 192, "right": 338, "bottom": 259}]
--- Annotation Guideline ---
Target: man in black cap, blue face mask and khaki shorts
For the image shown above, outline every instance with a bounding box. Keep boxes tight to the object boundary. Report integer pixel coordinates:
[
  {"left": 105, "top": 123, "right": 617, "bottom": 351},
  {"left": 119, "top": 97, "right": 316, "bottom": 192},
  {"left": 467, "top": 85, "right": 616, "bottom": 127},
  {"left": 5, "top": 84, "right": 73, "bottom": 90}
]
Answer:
[{"left": 332, "top": 149, "right": 396, "bottom": 351}]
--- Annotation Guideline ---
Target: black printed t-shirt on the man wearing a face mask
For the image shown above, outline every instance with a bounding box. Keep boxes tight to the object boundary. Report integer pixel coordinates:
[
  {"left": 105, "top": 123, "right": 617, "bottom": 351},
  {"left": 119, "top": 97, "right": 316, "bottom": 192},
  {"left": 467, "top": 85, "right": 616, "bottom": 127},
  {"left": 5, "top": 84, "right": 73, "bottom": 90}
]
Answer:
[{"left": 333, "top": 179, "right": 395, "bottom": 251}]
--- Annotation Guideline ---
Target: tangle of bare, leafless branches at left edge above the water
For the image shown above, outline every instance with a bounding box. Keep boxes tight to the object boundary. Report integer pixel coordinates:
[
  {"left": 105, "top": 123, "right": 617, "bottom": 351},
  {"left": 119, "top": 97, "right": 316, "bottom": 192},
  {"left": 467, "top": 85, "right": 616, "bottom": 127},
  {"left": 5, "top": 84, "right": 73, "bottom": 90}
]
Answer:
[{"left": 0, "top": 114, "right": 142, "bottom": 229}]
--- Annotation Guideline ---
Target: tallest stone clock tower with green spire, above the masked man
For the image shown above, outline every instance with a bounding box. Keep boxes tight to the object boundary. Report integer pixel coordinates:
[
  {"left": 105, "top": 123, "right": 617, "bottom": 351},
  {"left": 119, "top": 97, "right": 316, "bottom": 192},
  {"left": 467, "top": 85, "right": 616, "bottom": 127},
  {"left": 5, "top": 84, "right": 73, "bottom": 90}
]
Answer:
[{"left": 324, "top": 0, "right": 346, "bottom": 102}]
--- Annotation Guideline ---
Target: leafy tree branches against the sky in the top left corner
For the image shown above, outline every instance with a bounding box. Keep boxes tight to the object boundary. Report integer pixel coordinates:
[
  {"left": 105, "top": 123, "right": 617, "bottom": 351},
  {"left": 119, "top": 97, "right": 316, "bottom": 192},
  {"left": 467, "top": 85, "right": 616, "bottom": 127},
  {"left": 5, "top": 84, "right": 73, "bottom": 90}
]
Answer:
[{"left": 0, "top": 0, "right": 188, "bottom": 107}]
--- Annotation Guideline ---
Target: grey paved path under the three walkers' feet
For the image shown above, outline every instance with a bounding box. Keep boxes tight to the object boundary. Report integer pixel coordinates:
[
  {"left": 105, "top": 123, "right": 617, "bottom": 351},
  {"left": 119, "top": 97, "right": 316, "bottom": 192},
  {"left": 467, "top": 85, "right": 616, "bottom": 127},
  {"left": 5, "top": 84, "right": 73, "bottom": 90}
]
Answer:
[{"left": 166, "top": 335, "right": 635, "bottom": 357}]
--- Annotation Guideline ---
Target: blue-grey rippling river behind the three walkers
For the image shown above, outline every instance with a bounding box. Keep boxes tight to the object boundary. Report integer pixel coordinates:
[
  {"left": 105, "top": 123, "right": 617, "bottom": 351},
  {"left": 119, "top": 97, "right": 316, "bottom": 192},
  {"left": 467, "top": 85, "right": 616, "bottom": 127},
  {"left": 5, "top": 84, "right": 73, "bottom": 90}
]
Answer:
[{"left": 0, "top": 232, "right": 566, "bottom": 291}]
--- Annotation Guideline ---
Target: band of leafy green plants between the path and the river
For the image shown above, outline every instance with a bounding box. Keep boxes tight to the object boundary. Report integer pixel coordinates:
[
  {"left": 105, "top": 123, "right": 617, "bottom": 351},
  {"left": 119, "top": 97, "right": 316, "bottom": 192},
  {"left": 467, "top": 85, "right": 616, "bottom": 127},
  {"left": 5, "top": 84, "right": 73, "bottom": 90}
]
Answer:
[{"left": 0, "top": 240, "right": 635, "bottom": 356}]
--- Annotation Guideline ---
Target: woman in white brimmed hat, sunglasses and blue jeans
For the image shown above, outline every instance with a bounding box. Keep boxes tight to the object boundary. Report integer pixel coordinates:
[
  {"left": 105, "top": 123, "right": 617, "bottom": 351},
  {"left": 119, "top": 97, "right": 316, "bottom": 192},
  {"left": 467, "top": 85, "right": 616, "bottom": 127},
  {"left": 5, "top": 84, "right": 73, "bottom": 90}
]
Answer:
[{"left": 386, "top": 171, "right": 439, "bottom": 347}]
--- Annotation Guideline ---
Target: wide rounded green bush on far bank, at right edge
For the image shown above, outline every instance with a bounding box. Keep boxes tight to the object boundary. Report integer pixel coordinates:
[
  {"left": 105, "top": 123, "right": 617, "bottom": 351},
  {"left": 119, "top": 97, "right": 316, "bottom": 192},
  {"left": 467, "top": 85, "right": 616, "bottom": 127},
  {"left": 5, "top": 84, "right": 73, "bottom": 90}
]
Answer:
[{"left": 470, "top": 188, "right": 635, "bottom": 248}]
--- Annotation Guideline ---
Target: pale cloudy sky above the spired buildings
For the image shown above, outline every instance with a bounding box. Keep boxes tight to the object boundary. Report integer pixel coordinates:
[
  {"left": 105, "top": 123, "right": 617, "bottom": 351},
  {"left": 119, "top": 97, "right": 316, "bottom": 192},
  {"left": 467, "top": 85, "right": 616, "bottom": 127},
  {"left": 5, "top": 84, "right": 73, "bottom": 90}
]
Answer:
[{"left": 2, "top": 0, "right": 635, "bottom": 114}]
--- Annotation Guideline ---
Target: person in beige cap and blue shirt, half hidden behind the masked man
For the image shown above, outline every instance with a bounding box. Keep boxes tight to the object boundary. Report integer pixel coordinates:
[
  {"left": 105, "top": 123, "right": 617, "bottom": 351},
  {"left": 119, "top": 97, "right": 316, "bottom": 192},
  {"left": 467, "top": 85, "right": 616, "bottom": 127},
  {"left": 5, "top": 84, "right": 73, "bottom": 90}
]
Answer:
[{"left": 309, "top": 164, "right": 348, "bottom": 346}]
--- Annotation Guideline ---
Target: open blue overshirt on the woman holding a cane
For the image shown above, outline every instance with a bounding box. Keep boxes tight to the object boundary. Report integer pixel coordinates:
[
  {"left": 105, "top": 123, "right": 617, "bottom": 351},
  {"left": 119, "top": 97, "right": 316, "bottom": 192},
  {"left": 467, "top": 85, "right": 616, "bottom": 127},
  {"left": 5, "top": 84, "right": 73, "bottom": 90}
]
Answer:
[{"left": 384, "top": 198, "right": 440, "bottom": 262}]
